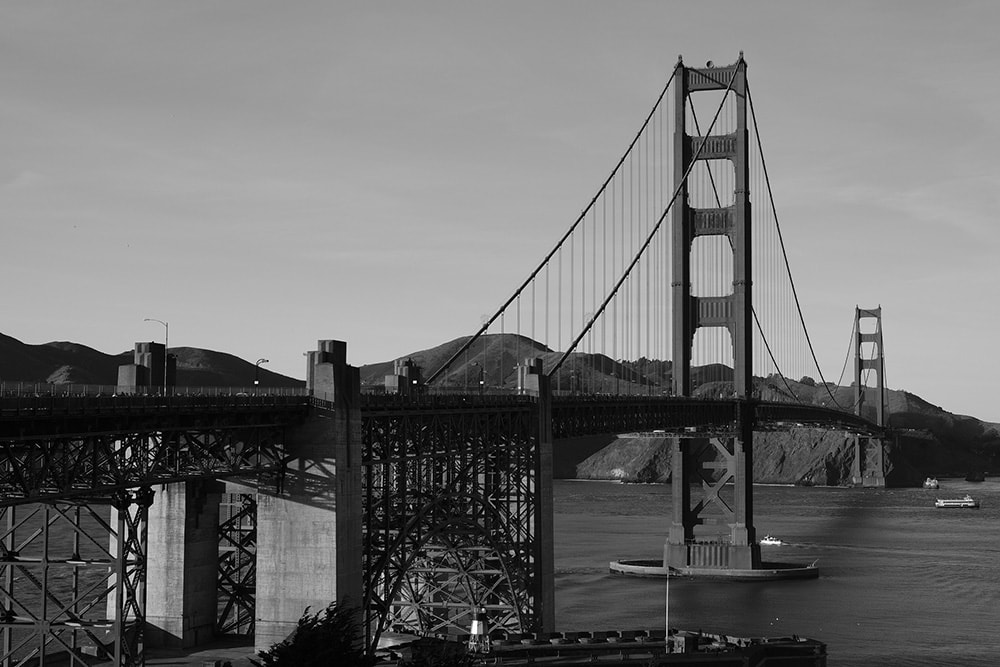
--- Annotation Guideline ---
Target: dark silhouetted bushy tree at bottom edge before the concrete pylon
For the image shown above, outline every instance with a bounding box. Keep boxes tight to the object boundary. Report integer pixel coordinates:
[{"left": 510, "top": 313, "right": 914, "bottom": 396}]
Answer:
[{"left": 250, "top": 602, "right": 373, "bottom": 667}]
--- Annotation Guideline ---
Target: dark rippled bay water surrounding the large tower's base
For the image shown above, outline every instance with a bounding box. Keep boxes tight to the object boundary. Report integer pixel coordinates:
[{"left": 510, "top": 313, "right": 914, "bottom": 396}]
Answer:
[{"left": 555, "top": 479, "right": 1000, "bottom": 666}]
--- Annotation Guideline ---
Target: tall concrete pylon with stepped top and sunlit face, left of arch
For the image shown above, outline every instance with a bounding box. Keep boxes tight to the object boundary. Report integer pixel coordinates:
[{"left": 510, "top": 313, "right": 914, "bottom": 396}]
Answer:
[{"left": 254, "top": 341, "right": 363, "bottom": 650}]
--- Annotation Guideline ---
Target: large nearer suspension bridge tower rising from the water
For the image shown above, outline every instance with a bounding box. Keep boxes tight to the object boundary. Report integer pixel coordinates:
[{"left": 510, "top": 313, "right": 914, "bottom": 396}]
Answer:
[{"left": 664, "top": 53, "right": 760, "bottom": 570}]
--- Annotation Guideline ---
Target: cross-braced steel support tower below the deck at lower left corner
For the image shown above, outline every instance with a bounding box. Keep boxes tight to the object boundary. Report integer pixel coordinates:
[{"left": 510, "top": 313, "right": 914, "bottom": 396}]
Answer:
[{"left": 0, "top": 489, "right": 152, "bottom": 667}]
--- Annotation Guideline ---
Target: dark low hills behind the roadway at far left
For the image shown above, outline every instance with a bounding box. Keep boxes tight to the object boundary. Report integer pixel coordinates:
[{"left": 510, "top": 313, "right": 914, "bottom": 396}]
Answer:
[{"left": 0, "top": 334, "right": 305, "bottom": 387}]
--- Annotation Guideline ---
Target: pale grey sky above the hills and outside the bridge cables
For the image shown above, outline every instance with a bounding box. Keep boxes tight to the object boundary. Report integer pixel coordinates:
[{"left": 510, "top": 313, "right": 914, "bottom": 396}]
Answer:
[{"left": 0, "top": 0, "right": 1000, "bottom": 422}]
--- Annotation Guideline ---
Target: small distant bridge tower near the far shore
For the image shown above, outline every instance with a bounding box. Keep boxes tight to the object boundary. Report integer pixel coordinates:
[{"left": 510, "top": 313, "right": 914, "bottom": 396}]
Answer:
[{"left": 851, "top": 306, "right": 886, "bottom": 487}]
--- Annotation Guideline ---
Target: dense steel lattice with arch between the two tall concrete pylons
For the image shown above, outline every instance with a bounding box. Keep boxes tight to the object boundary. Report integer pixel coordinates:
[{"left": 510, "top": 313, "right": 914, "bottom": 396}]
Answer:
[{"left": 362, "top": 397, "right": 542, "bottom": 643}]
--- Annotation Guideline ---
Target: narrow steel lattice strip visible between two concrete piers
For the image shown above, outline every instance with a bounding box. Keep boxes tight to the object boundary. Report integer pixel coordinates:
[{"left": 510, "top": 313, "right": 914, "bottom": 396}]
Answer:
[{"left": 216, "top": 493, "right": 257, "bottom": 637}]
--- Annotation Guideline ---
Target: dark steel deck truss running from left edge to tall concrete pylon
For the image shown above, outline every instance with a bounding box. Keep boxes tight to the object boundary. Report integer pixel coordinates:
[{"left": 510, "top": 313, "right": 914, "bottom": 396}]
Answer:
[{"left": 0, "top": 396, "right": 308, "bottom": 504}]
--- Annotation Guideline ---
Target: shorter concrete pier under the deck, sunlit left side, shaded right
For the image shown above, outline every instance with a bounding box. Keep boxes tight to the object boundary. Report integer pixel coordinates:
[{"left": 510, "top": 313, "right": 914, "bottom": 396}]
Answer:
[{"left": 146, "top": 480, "right": 223, "bottom": 648}]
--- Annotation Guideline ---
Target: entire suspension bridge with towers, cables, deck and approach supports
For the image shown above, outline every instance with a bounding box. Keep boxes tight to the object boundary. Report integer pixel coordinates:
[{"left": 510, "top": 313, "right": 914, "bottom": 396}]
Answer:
[{"left": 0, "top": 55, "right": 887, "bottom": 665}]
